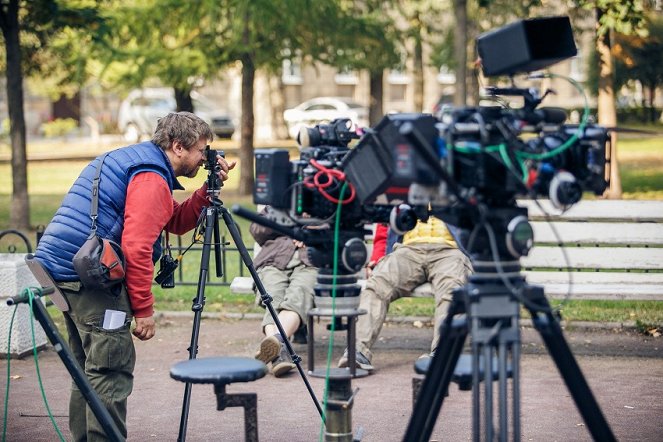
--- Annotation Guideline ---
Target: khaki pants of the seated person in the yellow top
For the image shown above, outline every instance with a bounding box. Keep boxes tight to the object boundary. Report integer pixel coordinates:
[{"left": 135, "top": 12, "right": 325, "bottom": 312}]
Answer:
[{"left": 357, "top": 244, "right": 472, "bottom": 359}]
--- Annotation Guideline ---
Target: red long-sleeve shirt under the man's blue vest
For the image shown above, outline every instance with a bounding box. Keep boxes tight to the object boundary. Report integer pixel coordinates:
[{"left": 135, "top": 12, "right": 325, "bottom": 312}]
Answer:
[{"left": 122, "top": 172, "right": 208, "bottom": 318}]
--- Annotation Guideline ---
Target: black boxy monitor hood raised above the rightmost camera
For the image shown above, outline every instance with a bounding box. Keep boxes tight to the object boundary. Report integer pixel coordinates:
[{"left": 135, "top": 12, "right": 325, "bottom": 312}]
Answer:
[{"left": 477, "top": 17, "right": 578, "bottom": 77}]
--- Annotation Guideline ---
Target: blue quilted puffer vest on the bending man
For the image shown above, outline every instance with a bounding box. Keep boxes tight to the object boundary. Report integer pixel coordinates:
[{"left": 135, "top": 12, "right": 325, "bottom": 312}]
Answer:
[{"left": 35, "top": 141, "right": 182, "bottom": 281}]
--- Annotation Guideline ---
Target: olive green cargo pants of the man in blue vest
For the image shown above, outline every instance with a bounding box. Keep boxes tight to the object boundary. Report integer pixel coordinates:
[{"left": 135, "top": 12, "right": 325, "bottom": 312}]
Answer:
[{"left": 58, "top": 282, "right": 136, "bottom": 442}]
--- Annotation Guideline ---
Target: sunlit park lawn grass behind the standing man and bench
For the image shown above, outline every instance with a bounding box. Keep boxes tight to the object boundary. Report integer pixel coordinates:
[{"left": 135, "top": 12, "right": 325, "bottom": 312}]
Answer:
[{"left": 0, "top": 135, "right": 663, "bottom": 329}]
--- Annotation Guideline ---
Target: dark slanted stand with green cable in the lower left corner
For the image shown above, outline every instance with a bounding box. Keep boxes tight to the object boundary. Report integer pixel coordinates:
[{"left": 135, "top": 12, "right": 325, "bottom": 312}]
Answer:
[{"left": 7, "top": 288, "right": 124, "bottom": 442}]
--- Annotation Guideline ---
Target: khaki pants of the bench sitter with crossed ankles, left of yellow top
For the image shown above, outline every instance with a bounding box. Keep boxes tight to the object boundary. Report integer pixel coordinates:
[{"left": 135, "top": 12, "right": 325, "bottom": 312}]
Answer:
[{"left": 256, "top": 253, "right": 318, "bottom": 330}]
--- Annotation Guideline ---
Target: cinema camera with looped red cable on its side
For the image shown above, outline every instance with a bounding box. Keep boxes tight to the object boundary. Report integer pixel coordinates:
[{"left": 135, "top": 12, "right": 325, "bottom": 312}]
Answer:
[{"left": 246, "top": 118, "right": 393, "bottom": 308}]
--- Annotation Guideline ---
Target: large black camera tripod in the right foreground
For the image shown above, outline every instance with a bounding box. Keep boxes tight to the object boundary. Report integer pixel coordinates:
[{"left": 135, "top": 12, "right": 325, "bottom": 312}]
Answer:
[{"left": 403, "top": 209, "right": 616, "bottom": 442}]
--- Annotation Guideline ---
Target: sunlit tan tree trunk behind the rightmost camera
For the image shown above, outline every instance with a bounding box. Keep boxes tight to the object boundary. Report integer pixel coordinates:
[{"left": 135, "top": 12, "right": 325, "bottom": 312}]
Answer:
[{"left": 596, "top": 9, "right": 622, "bottom": 199}]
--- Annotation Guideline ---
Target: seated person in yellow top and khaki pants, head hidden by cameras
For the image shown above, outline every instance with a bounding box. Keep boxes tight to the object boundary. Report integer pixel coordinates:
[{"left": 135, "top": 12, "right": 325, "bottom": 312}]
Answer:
[{"left": 338, "top": 217, "right": 472, "bottom": 371}]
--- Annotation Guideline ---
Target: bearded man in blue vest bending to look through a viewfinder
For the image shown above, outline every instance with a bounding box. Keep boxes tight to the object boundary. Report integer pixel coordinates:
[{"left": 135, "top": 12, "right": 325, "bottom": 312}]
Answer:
[{"left": 35, "top": 112, "right": 235, "bottom": 441}]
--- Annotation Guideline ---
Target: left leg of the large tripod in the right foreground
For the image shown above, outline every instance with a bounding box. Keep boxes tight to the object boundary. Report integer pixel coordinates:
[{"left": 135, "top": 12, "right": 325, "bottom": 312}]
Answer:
[{"left": 403, "top": 293, "right": 467, "bottom": 442}]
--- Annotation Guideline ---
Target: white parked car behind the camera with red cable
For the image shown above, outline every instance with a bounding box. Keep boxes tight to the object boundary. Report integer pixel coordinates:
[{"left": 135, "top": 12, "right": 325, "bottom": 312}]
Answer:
[{"left": 283, "top": 97, "right": 368, "bottom": 138}]
